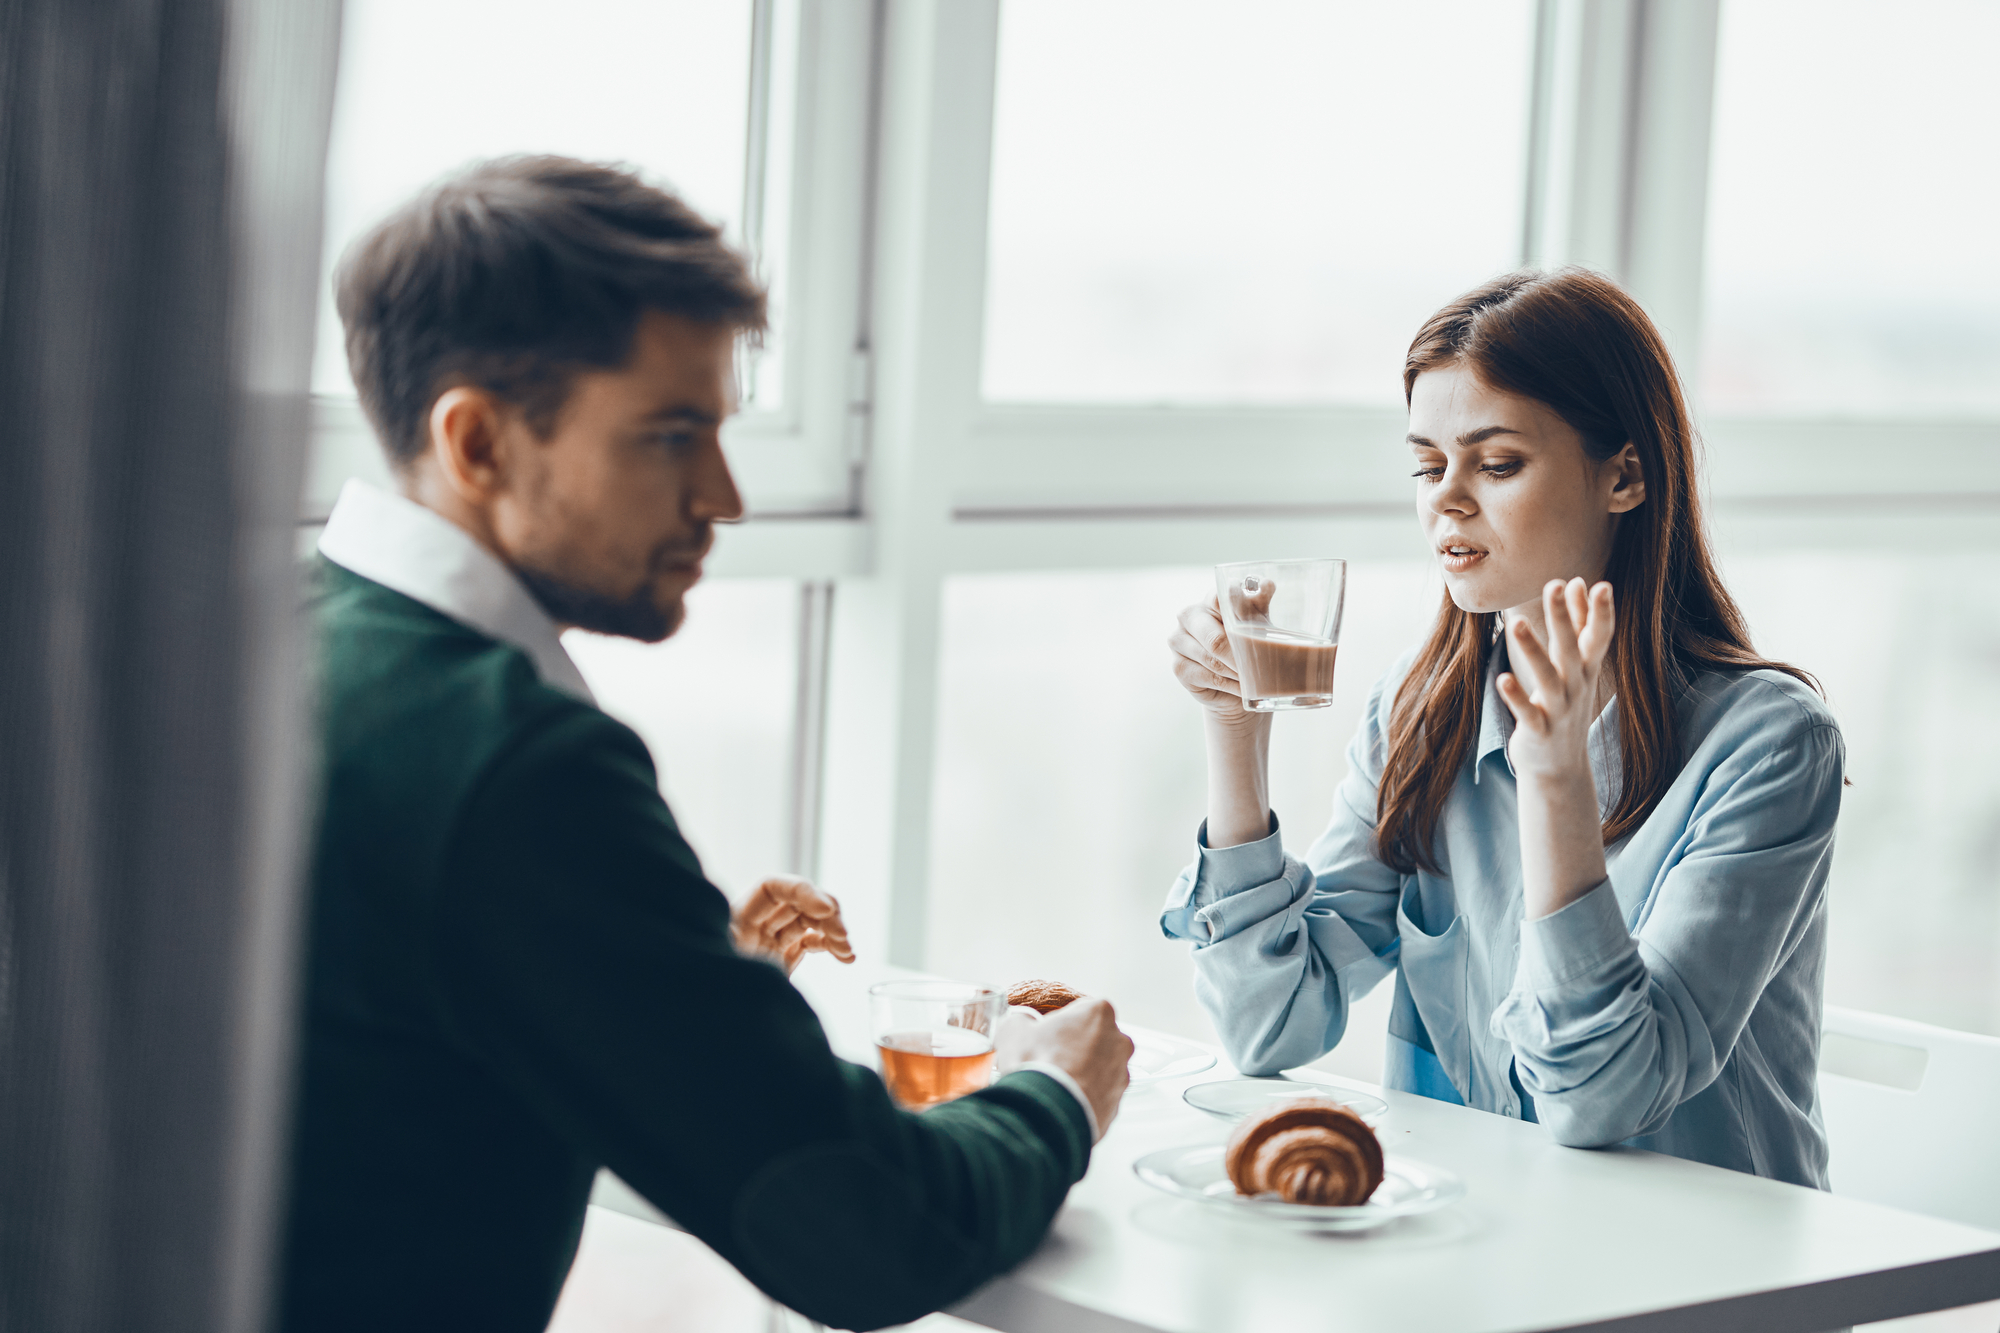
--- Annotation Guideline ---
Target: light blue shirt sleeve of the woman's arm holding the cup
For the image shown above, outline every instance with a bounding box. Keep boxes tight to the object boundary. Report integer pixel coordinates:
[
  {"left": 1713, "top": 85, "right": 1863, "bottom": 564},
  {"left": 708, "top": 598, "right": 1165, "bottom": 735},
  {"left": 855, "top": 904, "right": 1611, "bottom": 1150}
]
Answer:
[{"left": 1160, "top": 673, "right": 1402, "bottom": 1075}]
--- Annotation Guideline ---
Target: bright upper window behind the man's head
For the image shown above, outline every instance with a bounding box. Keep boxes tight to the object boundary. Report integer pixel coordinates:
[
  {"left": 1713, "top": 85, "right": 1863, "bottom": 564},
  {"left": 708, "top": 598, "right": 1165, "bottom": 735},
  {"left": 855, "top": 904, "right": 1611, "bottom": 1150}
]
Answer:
[{"left": 302, "top": 0, "right": 874, "bottom": 520}]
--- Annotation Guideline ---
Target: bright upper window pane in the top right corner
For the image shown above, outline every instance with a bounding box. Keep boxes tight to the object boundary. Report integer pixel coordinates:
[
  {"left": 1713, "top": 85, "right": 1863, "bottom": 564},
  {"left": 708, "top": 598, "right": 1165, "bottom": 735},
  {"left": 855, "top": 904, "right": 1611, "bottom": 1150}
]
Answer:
[{"left": 1702, "top": 0, "right": 2000, "bottom": 416}]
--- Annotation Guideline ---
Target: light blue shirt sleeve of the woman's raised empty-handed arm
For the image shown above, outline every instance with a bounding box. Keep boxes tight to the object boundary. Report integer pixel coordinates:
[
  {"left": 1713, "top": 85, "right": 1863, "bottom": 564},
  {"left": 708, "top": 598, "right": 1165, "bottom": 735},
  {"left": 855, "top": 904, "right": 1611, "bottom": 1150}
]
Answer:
[{"left": 1492, "top": 719, "right": 1844, "bottom": 1147}]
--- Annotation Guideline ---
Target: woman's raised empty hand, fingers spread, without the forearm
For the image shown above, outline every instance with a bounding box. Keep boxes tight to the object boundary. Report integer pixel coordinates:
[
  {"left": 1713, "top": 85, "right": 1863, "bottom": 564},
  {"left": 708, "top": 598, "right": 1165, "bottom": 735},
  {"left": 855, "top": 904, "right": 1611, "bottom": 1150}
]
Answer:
[{"left": 1496, "top": 578, "right": 1612, "bottom": 779}]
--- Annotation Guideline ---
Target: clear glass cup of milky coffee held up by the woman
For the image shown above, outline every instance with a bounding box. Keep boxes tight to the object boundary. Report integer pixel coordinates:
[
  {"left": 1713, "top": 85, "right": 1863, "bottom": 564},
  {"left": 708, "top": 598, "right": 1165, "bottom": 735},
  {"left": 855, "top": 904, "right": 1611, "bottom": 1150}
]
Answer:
[{"left": 1216, "top": 560, "right": 1348, "bottom": 713}]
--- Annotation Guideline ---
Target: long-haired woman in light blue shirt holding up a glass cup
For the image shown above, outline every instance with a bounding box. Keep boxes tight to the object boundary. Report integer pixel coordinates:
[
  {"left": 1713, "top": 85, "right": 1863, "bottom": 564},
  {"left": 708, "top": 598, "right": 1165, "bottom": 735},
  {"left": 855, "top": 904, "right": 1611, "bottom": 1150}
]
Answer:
[{"left": 1162, "top": 270, "right": 1842, "bottom": 1189}]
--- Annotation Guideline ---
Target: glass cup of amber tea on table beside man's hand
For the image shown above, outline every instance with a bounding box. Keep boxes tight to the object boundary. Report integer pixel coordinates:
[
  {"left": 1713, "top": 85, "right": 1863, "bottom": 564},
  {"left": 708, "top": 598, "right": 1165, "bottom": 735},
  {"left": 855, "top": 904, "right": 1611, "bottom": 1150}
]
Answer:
[{"left": 868, "top": 981, "right": 1008, "bottom": 1111}]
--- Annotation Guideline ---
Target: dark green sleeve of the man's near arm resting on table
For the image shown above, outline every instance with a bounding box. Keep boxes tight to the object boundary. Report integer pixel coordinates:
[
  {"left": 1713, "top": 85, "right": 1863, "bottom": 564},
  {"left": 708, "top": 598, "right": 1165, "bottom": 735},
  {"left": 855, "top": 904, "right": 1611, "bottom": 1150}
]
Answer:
[{"left": 434, "top": 709, "right": 1090, "bottom": 1329}]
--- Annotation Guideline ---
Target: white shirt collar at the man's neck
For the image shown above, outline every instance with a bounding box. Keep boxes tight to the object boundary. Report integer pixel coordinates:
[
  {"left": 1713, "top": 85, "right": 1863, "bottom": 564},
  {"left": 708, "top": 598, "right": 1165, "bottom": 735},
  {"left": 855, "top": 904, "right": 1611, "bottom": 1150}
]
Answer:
[{"left": 320, "top": 480, "right": 596, "bottom": 703}]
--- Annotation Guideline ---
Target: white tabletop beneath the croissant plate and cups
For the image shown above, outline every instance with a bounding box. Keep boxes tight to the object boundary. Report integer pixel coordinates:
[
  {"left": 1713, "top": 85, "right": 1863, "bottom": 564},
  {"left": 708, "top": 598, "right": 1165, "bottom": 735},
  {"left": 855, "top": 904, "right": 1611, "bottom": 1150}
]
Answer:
[{"left": 760, "top": 959, "right": 2000, "bottom": 1333}]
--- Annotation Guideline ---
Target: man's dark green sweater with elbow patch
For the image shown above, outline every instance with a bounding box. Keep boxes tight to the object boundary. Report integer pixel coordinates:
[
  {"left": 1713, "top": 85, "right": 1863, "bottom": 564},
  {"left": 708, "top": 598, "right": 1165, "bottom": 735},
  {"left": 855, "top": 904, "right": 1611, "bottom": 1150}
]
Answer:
[{"left": 282, "top": 560, "right": 1090, "bottom": 1333}]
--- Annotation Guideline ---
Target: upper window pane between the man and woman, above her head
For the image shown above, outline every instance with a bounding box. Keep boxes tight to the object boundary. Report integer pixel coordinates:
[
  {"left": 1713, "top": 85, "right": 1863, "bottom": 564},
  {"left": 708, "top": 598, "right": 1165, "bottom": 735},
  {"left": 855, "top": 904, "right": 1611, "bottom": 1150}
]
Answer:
[{"left": 984, "top": 0, "right": 1534, "bottom": 402}]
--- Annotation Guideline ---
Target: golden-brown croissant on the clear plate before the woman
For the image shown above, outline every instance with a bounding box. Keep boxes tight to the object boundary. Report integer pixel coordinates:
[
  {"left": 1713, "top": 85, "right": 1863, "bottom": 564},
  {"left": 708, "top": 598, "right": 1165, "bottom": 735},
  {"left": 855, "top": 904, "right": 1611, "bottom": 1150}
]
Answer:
[{"left": 1222, "top": 1097, "right": 1382, "bottom": 1207}]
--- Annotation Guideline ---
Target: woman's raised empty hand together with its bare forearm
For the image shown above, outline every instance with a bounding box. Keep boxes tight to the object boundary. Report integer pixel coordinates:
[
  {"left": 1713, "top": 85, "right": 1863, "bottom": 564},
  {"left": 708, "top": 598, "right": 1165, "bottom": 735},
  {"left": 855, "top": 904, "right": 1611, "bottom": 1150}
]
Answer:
[{"left": 1496, "top": 578, "right": 1612, "bottom": 921}]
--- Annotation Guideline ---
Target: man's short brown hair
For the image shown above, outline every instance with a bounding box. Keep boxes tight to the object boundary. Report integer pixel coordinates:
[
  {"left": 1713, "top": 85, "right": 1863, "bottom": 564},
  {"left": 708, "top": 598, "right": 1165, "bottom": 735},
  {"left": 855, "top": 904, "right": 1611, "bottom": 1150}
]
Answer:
[{"left": 334, "top": 156, "right": 764, "bottom": 468}]
